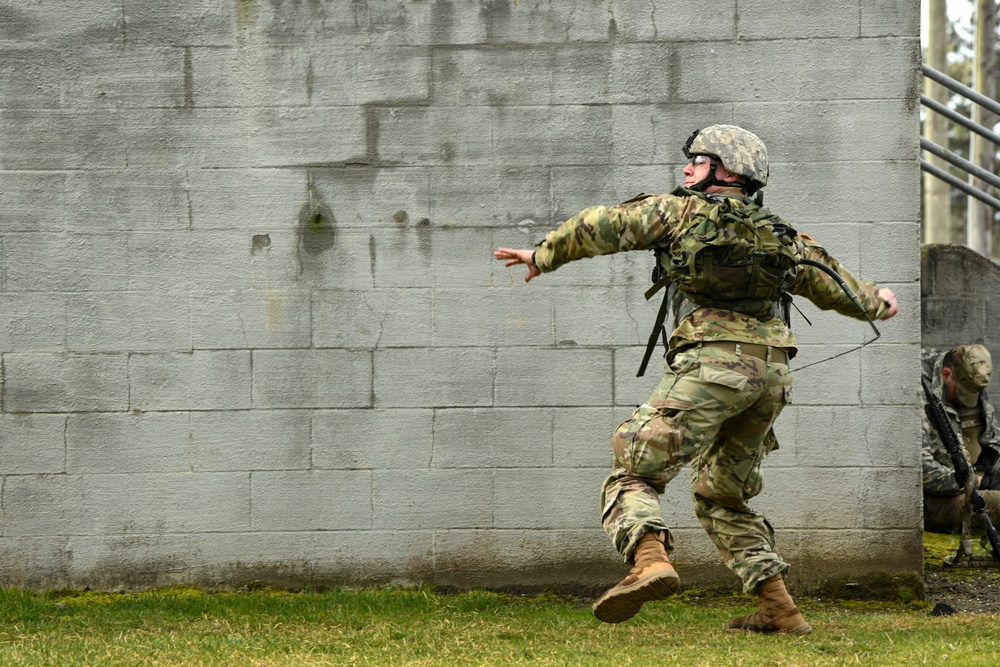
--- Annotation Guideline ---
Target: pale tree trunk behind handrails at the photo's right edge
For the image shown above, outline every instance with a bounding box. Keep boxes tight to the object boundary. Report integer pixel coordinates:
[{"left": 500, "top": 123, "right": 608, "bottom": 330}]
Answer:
[{"left": 966, "top": 0, "right": 996, "bottom": 257}]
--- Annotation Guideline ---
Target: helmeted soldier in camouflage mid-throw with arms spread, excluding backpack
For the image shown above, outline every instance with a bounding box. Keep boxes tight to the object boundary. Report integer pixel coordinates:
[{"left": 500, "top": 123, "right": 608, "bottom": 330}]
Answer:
[{"left": 495, "top": 125, "right": 897, "bottom": 634}]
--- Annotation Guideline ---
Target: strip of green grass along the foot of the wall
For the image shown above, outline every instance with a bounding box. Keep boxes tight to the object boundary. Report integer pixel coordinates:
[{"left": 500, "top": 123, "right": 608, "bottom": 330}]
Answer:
[{"left": 0, "top": 588, "right": 1000, "bottom": 667}]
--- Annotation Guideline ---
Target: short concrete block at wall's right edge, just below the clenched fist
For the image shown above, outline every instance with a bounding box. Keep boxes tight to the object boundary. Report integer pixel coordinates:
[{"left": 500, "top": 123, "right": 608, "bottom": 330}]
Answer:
[{"left": 861, "top": 343, "right": 921, "bottom": 405}]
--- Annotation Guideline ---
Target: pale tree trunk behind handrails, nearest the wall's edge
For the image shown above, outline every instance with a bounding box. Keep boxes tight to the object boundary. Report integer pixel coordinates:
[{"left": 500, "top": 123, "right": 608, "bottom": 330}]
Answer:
[{"left": 923, "top": 0, "right": 951, "bottom": 243}]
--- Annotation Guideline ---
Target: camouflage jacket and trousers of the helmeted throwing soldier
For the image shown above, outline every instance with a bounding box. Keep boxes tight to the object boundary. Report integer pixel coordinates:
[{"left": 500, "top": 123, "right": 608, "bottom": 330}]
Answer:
[{"left": 534, "top": 189, "right": 888, "bottom": 592}]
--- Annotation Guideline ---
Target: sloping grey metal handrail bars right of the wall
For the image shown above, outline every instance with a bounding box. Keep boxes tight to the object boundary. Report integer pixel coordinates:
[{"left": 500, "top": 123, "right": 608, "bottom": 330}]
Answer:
[{"left": 920, "top": 64, "right": 1000, "bottom": 211}]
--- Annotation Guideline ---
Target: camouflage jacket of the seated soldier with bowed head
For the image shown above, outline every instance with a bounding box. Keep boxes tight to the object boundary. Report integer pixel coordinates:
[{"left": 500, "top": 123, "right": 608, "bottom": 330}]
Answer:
[{"left": 920, "top": 350, "right": 1000, "bottom": 496}]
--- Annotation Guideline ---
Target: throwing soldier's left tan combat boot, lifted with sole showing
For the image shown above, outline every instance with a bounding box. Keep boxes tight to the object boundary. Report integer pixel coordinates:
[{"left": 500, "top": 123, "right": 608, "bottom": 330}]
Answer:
[{"left": 594, "top": 531, "right": 681, "bottom": 623}]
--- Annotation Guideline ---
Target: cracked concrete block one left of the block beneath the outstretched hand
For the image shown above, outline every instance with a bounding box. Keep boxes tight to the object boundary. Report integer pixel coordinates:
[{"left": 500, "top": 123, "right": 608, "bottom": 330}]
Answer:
[{"left": 311, "top": 288, "right": 432, "bottom": 350}]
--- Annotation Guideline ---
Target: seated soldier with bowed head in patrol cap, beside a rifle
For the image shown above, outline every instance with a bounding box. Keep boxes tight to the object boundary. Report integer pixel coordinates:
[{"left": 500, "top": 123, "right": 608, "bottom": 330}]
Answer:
[{"left": 921, "top": 345, "right": 1000, "bottom": 533}]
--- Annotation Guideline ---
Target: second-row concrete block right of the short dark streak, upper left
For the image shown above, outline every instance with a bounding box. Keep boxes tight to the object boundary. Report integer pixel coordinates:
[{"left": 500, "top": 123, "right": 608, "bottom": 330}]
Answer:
[{"left": 187, "top": 44, "right": 311, "bottom": 108}]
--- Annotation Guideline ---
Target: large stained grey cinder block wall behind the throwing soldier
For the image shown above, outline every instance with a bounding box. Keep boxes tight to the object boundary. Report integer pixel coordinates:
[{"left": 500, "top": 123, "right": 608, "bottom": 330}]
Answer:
[{"left": 0, "top": 0, "right": 921, "bottom": 588}]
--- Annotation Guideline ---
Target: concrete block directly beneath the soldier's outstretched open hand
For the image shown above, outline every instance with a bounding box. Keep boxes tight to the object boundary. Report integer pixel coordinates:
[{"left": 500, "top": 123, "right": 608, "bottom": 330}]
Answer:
[{"left": 433, "top": 288, "right": 554, "bottom": 347}]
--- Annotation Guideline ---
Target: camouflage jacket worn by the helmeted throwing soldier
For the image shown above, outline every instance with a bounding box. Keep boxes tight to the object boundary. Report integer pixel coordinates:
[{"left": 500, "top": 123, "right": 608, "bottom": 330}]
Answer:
[{"left": 534, "top": 189, "right": 888, "bottom": 356}]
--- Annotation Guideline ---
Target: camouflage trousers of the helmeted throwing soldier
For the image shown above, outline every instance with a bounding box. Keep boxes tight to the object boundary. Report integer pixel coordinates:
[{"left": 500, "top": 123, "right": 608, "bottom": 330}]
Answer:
[{"left": 601, "top": 344, "right": 792, "bottom": 593}]
